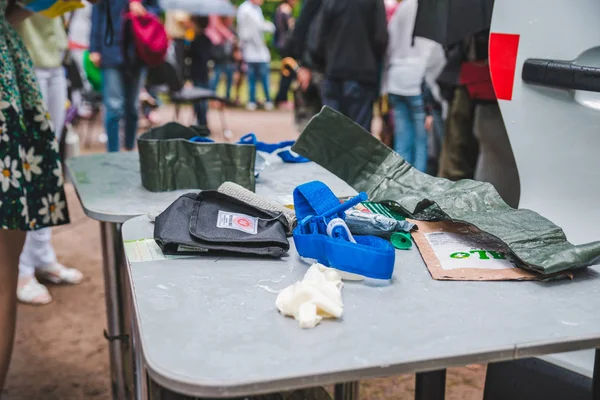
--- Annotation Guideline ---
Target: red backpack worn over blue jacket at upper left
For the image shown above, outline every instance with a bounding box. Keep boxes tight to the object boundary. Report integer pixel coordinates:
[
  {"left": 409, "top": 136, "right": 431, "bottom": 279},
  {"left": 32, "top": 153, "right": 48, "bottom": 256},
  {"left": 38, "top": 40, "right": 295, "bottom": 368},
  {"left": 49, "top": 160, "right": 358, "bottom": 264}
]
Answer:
[{"left": 125, "top": 13, "right": 169, "bottom": 67}]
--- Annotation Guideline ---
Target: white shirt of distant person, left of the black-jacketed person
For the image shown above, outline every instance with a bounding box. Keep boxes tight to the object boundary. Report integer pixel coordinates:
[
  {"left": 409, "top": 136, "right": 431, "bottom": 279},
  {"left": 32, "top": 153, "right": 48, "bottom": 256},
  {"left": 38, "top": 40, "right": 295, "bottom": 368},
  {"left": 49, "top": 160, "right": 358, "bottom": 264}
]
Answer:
[{"left": 237, "top": 0, "right": 275, "bottom": 63}]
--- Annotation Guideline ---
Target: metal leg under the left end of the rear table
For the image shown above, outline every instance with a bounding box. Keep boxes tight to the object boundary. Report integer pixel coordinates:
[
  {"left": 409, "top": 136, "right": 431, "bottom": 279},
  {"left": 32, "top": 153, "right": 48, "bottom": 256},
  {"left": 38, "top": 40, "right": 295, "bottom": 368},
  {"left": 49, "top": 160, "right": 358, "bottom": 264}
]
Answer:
[{"left": 100, "top": 222, "right": 125, "bottom": 399}]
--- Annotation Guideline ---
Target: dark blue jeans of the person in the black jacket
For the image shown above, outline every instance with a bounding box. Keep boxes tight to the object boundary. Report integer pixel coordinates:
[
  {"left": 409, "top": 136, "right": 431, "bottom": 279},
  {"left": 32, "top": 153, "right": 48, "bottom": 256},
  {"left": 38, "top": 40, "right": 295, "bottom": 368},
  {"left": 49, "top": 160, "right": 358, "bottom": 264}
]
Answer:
[{"left": 321, "top": 79, "right": 377, "bottom": 132}]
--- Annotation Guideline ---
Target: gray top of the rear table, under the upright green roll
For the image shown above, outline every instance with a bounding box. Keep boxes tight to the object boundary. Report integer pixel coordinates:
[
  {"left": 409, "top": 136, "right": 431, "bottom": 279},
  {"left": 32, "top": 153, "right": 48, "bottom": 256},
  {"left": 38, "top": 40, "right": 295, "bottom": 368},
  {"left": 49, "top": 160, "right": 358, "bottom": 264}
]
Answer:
[{"left": 67, "top": 152, "right": 356, "bottom": 223}]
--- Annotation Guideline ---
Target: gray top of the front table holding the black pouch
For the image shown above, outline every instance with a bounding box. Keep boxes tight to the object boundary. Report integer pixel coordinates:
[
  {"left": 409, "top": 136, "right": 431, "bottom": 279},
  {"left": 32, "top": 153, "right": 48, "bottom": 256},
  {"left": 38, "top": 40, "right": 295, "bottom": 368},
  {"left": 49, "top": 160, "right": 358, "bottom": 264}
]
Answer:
[{"left": 123, "top": 217, "right": 600, "bottom": 397}]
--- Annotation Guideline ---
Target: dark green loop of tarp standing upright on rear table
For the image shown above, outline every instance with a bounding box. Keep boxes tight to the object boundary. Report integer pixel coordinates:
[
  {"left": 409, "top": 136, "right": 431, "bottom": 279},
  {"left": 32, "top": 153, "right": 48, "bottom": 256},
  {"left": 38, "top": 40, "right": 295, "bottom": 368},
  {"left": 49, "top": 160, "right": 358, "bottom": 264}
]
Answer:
[{"left": 138, "top": 122, "right": 256, "bottom": 192}]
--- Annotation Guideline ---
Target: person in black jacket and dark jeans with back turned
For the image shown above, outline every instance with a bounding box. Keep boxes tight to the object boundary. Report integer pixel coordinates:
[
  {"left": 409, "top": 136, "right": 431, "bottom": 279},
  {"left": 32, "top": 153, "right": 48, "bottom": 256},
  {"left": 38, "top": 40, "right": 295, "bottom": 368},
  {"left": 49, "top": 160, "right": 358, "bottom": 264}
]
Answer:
[{"left": 313, "top": 0, "right": 388, "bottom": 132}]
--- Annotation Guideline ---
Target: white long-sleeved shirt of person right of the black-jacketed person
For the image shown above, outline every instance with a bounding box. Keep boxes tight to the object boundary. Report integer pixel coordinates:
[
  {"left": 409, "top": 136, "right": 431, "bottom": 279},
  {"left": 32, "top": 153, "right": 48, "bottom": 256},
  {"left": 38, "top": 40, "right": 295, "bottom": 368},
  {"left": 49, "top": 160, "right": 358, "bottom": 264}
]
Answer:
[{"left": 383, "top": 0, "right": 446, "bottom": 96}]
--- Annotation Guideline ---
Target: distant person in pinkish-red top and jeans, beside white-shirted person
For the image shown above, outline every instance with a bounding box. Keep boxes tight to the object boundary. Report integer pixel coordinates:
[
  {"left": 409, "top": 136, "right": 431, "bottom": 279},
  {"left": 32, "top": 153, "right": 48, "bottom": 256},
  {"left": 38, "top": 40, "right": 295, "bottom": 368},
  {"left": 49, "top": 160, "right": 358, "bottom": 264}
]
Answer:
[{"left": 206, "top": 15, "right": 237, "bottom": 101}]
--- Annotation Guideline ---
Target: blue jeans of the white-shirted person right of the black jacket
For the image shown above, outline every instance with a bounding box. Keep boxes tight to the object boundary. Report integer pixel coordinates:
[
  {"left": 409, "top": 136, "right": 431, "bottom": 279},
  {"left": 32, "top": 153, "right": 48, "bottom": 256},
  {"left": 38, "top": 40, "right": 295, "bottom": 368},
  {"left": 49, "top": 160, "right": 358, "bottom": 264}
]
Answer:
[{"left": 389, "top": 94, "right": 427, "bottom": 172}]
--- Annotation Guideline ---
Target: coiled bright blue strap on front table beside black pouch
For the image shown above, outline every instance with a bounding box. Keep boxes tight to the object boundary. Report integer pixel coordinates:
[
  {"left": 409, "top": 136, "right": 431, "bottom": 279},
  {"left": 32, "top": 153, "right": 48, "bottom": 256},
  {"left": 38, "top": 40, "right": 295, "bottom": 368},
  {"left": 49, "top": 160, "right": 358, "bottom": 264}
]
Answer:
[{"left": 293, "top": 181, "right": 396, "bottom": 279}]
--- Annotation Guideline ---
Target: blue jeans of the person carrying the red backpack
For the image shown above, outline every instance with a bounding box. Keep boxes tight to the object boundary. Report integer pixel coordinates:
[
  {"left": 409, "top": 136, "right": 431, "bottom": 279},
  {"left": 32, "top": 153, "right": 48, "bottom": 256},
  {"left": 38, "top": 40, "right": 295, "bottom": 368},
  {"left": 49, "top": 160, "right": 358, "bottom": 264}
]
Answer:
[{"left": 102, "top": 68, "right": 144, "bottom": 152}]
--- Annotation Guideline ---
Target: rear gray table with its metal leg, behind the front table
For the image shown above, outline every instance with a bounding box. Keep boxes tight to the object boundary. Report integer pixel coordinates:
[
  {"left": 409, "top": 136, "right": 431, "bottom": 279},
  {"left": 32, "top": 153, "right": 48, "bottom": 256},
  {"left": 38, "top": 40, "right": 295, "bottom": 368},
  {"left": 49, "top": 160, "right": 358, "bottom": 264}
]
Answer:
[{"left": 67, "top": 152, "right": 356, "bottom": 399}]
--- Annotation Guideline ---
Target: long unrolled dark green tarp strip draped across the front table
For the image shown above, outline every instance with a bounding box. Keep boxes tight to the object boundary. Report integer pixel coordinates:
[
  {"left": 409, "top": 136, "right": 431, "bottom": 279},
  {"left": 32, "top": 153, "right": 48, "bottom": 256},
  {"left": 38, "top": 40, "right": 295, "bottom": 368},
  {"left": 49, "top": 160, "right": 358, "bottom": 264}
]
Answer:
[{"left": 293, "top": 107, "right": 600, "bottom": 275}]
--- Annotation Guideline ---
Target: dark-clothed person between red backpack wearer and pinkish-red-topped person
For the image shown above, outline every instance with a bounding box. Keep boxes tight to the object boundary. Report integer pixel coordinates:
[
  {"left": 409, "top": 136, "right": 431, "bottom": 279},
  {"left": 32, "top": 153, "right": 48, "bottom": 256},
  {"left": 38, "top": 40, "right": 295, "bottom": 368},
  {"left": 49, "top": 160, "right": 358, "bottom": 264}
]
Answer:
[{"left": 190, "top": 16, "right": 213, "bottom": 126}]
